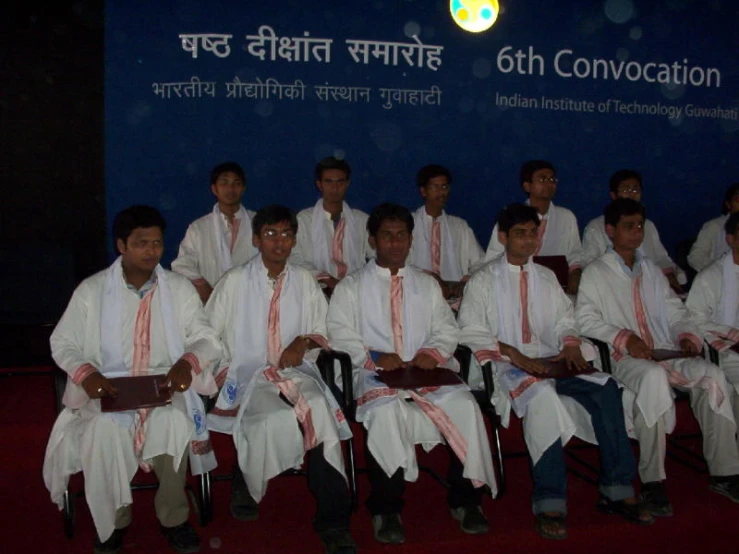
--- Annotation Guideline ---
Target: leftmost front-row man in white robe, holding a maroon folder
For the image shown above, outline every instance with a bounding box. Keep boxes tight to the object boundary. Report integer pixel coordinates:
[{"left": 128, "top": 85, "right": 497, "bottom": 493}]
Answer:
[{"left": 43, "top": 206, "right": 221, "bottom": 554}]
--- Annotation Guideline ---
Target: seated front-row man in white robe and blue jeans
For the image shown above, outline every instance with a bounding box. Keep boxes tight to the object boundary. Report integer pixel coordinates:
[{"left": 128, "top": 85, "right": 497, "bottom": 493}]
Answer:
[{"left": 458, "top": 204, "right": 654, "bottom": 539}]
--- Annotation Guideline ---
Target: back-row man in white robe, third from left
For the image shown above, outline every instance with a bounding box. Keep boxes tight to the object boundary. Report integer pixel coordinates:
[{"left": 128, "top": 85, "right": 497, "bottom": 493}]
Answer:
[{"left": 409, "top": 165, "right": 484, "bottom": 299}]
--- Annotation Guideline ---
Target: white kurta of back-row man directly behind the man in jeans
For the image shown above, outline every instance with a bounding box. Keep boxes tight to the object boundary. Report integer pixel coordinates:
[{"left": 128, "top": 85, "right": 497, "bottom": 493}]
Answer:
[{"left": 485, "top": 203, "right": 582, "bottom": 270}]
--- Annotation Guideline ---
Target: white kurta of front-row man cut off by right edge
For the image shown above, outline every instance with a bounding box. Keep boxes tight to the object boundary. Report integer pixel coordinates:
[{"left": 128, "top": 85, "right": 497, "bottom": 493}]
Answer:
[{"left": 685, "top": 252, "right": 739, "bottom": 398}]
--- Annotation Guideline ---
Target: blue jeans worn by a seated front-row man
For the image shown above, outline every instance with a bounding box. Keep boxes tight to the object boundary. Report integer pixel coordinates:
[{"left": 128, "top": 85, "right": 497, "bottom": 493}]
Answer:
[{"left": 531, "top": 377, "right": 636, "bottom": 514}]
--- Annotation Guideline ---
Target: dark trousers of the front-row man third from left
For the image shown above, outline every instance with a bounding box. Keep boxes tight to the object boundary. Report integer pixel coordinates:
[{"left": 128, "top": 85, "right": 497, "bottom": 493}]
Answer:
[{"left": 365, "top": 445, "right": 482, "bottom": 516}]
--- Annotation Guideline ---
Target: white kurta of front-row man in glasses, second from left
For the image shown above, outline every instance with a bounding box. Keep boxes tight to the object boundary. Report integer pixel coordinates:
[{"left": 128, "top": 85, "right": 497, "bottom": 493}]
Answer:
[{"left": 206, "top": 256, "right": 351, "bottom": 501}]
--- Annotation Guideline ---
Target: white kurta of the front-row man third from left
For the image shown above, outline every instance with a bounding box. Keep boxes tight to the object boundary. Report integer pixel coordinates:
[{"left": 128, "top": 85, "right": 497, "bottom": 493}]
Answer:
[{"left": 327, "top": 261, "right": 497, "bottom": 494}]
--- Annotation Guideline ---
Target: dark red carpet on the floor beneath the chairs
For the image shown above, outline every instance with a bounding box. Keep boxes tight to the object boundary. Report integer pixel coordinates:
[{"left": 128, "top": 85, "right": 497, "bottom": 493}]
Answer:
[{"left": 0, "top": 375, "right": 739, "bottom": 554}]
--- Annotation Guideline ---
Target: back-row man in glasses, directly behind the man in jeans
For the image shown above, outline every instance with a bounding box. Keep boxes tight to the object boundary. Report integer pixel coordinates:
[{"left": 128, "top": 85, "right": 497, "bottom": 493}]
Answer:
[{"left": 485, "top": 160, "right": 582, "bottom": 294}]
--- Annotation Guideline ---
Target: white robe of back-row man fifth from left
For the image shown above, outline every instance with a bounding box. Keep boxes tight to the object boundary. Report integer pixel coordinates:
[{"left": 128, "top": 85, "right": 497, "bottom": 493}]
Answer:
[{"left": 582, "top": 211, "right": 687, "bottom": 284}]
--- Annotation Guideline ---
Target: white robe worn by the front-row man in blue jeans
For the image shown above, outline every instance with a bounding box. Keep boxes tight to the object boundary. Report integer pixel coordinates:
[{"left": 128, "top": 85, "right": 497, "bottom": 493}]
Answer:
[{"left": 458, "top": 255, "right": 608, "bottom": 464}]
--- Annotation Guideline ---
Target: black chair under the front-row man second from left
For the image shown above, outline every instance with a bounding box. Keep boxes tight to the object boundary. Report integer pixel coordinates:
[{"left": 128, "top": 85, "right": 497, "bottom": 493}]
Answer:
[{"left": 199, "top": 350, "right": 357, "bottom": 525}]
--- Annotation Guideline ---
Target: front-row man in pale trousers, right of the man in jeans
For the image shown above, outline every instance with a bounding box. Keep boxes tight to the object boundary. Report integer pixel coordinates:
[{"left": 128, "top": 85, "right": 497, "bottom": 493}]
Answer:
[{"left": 575, "top": 198, "right": 739, "bottom": 516}]
